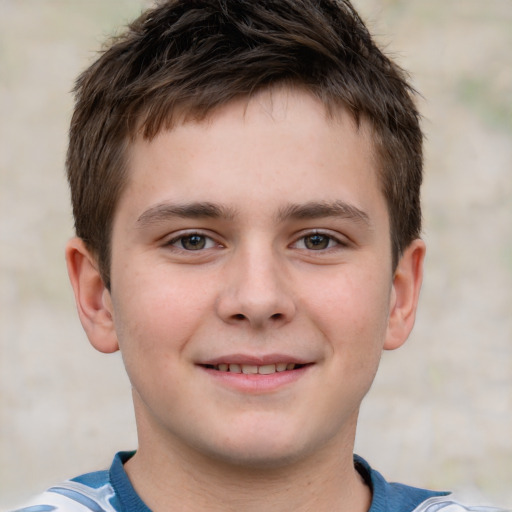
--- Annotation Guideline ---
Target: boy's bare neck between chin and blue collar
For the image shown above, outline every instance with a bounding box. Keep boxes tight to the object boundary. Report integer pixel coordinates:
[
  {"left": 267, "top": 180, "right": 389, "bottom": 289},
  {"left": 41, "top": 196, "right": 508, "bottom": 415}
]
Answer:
[{"left": 125, "top": 420, "right": 371, "bottom": 512}]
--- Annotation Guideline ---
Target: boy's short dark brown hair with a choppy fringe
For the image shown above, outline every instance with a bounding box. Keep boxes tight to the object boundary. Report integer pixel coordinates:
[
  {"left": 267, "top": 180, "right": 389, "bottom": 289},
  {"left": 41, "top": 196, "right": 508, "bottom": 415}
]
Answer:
[{"left": 67, "top": 0, "right": 422, "bottom": 287}]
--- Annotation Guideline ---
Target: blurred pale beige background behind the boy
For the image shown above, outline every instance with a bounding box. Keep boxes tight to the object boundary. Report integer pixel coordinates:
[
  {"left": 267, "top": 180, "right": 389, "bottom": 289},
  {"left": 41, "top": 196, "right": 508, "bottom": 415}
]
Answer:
[{"left": 0, "top": 0, "right": 512, "bottom": 509}]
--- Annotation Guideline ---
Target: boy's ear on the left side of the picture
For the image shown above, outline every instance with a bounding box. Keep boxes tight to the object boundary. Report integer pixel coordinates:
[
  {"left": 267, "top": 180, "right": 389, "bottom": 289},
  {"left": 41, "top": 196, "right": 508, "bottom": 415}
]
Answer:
[{"left": 66, "top": 238, "right": 119, "bottom": 353}]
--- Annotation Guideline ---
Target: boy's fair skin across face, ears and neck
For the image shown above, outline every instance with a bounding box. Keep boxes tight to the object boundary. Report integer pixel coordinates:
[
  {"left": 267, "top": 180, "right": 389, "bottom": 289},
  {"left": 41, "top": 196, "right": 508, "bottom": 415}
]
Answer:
[{"left": 66, "top": 89, "right": 425, "bottom": 512}]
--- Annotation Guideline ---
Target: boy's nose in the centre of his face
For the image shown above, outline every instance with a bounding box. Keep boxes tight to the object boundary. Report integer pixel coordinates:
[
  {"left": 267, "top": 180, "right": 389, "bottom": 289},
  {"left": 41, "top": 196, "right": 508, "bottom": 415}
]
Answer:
[{"left": 217, "top": 243, "right": 296, "bottom": 329}]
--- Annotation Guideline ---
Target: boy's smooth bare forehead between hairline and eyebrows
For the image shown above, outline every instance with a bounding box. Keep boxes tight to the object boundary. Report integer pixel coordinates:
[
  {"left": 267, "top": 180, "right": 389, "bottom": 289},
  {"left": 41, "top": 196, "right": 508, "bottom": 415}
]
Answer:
[{"left": 120, "top": 88, "right": 379, "bottom": 223}]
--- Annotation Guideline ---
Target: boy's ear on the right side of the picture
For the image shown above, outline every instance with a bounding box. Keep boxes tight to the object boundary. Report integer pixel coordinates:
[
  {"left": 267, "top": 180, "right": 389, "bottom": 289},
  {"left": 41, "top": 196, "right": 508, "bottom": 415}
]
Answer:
[{"left": 384, "top": 239, "right": 426, "bottom": 350}]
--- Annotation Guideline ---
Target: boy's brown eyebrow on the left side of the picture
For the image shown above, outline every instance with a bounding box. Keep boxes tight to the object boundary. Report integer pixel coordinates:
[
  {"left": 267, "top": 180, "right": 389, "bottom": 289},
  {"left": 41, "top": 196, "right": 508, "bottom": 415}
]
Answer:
[{"left": 137, "top": 202, "right": 235, "bottom": 226}]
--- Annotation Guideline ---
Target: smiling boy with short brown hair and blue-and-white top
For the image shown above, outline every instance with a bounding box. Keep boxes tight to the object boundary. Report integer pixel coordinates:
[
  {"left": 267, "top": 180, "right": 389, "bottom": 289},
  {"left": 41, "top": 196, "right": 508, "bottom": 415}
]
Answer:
[{"left": 13, "top": 0, "right": 508, "bottom": 512}]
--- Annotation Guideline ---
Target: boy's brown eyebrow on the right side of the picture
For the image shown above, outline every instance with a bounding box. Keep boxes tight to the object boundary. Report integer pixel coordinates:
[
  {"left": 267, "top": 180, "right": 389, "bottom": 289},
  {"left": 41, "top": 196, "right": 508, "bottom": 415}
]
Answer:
[{"left": 277, "top": 201, "right": 372, "bottom": 227}]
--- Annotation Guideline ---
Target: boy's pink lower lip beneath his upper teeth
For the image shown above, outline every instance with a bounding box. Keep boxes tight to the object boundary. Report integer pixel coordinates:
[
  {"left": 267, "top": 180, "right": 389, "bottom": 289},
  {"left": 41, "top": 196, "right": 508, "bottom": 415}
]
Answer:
[{"left": 200, "top": 365, "right": 313, "bottom": 394}]
